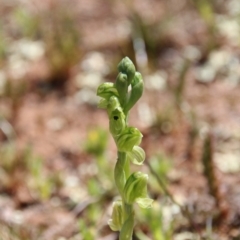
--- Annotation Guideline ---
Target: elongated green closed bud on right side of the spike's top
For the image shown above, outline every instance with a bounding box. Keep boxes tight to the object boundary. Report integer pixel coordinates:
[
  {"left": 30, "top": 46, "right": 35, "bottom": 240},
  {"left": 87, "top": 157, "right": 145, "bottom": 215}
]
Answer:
[{"left": 124, "top": 72, "right": 144, "bottom": 112}]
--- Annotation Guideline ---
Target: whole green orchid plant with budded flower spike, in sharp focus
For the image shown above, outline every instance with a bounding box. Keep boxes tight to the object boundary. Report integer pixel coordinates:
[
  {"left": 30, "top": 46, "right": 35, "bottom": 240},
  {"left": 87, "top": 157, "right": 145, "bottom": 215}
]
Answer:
[{"left": 97, "top": 57, "right": 153, "bottom": 240}]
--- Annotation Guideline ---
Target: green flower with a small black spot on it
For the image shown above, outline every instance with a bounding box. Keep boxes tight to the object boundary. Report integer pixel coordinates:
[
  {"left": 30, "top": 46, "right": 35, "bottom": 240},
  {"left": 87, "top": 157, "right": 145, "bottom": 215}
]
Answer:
[{"left": 109, "top": 107, "right": 126, "bottom": 137}]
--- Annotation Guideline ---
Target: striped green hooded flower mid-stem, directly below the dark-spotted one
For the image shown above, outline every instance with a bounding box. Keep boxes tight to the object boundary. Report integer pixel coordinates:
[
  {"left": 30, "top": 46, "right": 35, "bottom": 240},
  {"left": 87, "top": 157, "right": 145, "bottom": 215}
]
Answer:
[{"left": 115, "top": 127, "right": 142, "bottom": 152}]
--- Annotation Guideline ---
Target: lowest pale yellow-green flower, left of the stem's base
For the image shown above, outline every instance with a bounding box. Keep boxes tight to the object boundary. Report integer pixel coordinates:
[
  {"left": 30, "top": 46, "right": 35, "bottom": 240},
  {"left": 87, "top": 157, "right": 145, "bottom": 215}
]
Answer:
[{"left": 108, "top": 200, "right": 124, "bottom": 231}]
